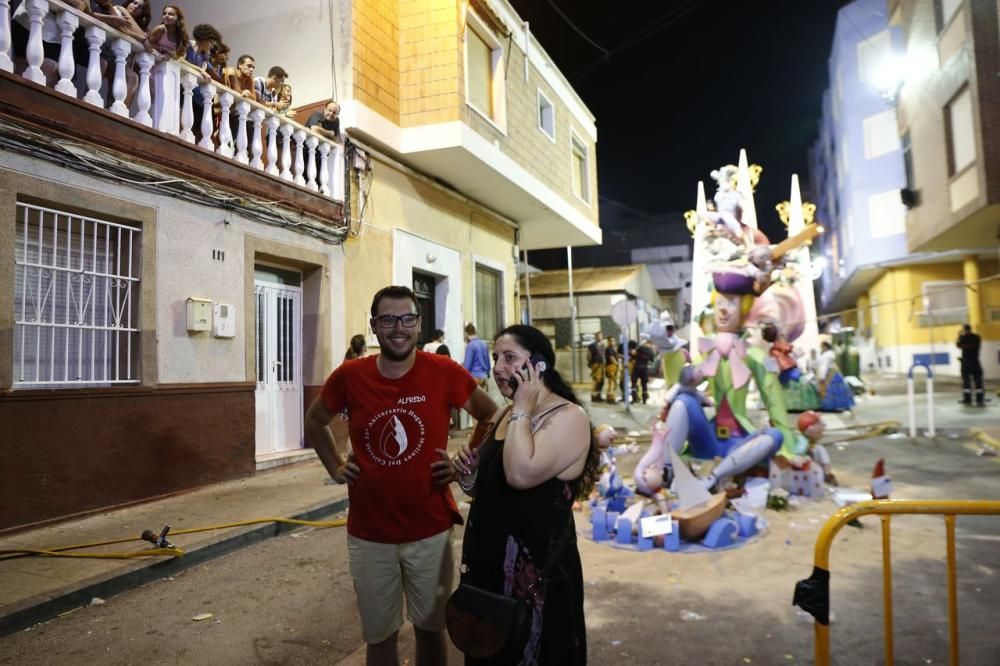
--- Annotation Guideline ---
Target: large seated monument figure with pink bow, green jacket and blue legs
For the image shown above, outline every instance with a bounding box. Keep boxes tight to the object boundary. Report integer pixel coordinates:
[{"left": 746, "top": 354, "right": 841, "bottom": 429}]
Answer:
[{"left": 659, "top": 271, "right": 794, "bottom": 490}]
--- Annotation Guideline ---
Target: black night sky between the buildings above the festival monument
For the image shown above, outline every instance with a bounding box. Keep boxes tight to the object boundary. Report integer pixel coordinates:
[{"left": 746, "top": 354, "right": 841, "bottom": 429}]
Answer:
[{"left": 510, "top": 0, "right": 847, "bottom": 263}]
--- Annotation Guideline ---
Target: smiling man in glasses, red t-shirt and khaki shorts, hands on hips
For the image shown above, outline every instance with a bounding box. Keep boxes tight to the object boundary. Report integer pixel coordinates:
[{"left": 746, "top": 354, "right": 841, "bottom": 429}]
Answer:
[{"left": 305, "top": 286, "right": 497, "bottom": 664}]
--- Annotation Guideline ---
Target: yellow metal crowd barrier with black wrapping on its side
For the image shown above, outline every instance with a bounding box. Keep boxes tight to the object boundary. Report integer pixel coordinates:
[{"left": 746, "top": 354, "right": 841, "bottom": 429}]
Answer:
[{"left": 792, "top": 500, "right": 1000, "bottom": 666}]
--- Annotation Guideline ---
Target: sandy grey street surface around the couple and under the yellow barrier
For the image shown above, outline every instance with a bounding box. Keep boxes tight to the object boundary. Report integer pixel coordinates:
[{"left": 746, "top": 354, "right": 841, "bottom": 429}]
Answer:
[{"left": 0, "top": 418, "right": 1000, "bottom": 666}]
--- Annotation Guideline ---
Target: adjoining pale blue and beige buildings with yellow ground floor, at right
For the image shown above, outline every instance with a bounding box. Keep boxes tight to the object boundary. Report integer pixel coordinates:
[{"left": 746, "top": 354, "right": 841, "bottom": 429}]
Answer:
[{"left": 811, "top": 0, "right": 1000, "bottom": 377}]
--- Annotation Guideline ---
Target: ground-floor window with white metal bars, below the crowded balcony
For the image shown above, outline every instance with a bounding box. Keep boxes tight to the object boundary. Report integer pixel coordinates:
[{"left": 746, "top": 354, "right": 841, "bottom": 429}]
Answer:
[{"left": 14, "top": 203, "right": 142, "bottom": 388}]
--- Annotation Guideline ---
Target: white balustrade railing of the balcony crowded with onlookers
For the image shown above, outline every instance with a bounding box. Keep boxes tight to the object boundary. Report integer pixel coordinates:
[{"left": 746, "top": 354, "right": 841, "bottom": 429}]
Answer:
[{"left": 0, "top": 0, "right": 344, "bottom": 202}]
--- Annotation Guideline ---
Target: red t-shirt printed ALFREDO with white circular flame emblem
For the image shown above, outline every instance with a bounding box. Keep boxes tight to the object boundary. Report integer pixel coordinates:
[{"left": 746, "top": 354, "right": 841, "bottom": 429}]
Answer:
[{"left": 320, "top": 351, "right": 477, "bottom": 544}]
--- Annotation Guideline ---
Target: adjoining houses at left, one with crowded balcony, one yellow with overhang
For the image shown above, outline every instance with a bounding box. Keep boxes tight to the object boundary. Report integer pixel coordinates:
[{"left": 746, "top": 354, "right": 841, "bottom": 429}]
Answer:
[{"left": 0, "top": 0, "right": 600, "bottom": 530}]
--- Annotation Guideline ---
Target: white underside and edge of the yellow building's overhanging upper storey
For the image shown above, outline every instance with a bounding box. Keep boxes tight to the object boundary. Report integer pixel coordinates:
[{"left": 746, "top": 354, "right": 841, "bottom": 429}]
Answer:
[{"left": 340, "top": 100, "right": 601, "bottom": 250}]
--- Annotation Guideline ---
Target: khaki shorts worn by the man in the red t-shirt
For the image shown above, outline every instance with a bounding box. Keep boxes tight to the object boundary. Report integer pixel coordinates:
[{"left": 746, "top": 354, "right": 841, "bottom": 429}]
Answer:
[{"left": 347, "top": 529, "right": 455, "bottom": 644}]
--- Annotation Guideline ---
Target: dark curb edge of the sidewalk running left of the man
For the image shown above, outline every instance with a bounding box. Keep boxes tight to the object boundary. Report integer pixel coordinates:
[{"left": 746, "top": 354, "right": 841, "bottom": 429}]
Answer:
[{"left": 0, "top": 497, "right": 348, "bottom": 638}]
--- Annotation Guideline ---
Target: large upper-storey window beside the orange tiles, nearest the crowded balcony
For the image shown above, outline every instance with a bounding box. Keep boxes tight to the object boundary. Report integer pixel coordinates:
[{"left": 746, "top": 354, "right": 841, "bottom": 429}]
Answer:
[{"left": 465, "top": 11, "right": 507, "bottom": 131}]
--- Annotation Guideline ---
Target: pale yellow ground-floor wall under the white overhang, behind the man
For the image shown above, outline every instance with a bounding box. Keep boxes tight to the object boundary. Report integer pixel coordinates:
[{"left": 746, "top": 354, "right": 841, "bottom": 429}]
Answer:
[{"left": 344, "top": 159, "right": 517, "bottom": 335}]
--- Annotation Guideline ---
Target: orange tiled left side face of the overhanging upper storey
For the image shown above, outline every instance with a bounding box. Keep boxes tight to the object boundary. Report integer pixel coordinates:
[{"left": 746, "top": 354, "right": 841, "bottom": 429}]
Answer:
[{"left": 351, "top": 0, "right": 398, "bottom": 125}]
